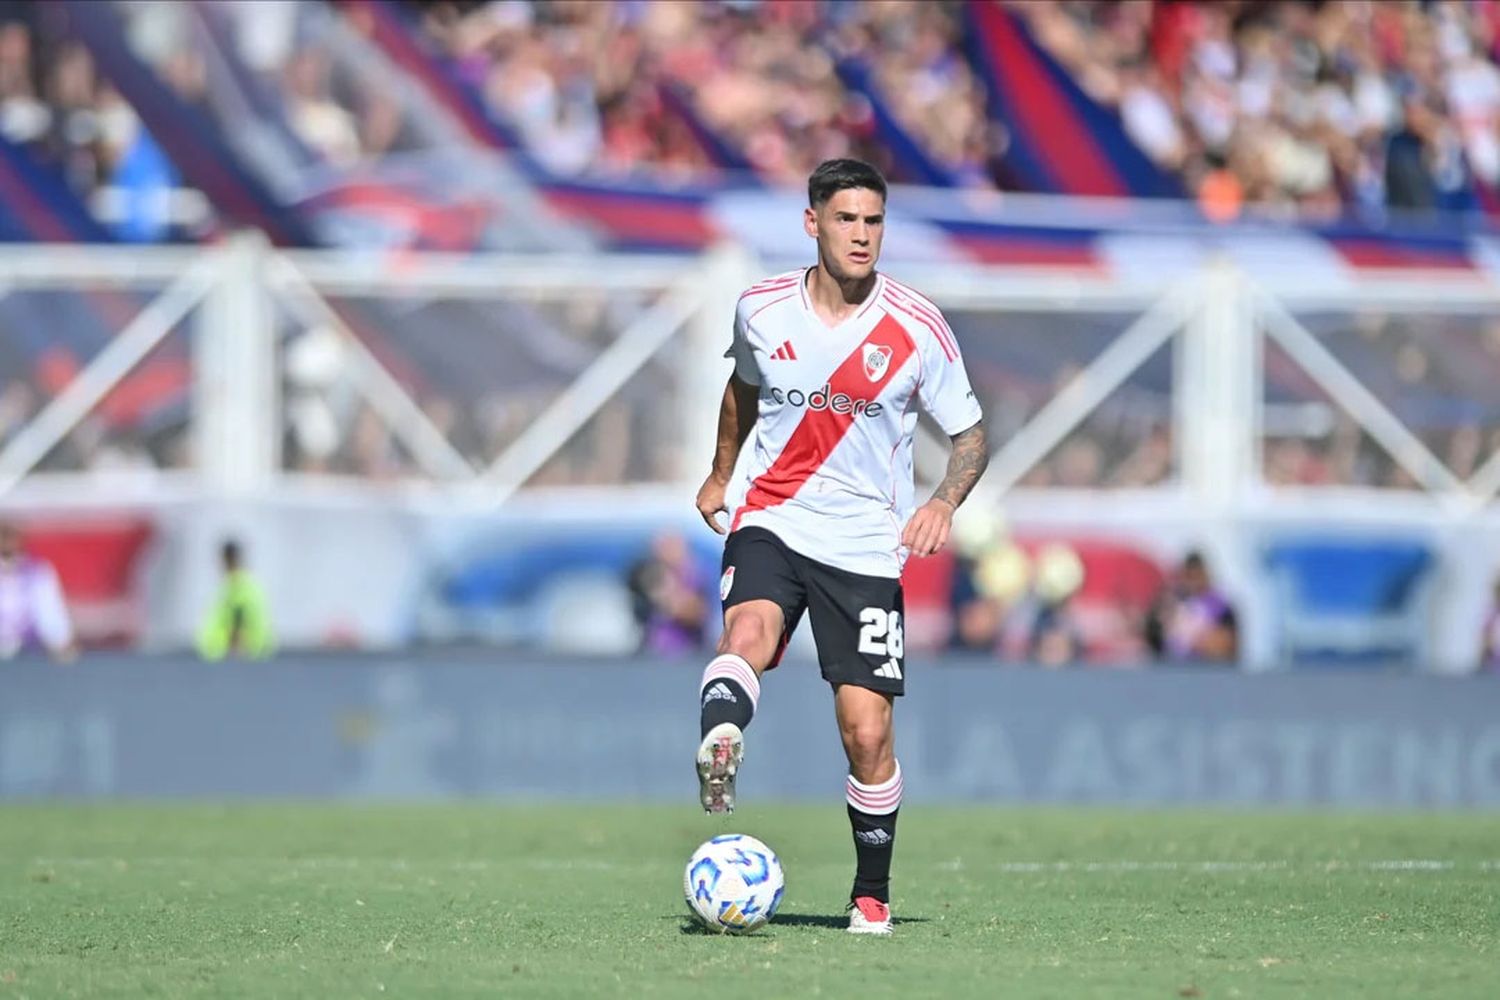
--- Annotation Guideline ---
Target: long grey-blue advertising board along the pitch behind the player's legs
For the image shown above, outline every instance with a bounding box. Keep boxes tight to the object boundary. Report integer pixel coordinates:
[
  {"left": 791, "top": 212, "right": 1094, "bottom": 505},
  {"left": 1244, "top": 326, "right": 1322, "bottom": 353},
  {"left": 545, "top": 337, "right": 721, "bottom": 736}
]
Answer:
[{"left": 0, "top": 655, "right": 1500, "bottom": 810}]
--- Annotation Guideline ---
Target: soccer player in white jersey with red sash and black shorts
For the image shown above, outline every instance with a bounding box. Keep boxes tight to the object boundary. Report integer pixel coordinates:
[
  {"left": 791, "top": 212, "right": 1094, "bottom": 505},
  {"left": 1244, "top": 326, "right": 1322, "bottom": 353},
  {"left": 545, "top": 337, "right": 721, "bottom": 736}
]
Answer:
[{"left": 696, "top": 159, "right": 989, "bottom": 934}]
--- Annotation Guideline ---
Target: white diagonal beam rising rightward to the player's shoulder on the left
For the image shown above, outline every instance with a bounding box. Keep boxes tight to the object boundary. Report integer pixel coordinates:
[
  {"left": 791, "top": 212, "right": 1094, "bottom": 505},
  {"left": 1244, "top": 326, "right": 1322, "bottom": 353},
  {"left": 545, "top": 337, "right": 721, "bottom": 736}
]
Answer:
[{"left": 480, "top": 280, "right": 705, "bottom": 507}]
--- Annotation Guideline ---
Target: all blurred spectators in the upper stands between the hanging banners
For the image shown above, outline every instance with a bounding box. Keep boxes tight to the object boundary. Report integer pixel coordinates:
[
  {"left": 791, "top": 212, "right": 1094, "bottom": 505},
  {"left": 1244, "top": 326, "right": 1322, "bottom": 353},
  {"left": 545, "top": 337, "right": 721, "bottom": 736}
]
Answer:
[{"left": 0, "top": 0, "right": 1500, "bottom": 217}]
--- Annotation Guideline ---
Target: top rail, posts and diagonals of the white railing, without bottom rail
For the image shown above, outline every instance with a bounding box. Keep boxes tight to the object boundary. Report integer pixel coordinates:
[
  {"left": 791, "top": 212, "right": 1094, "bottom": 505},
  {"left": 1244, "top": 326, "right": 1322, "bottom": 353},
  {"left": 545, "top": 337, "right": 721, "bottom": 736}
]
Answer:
[{"left": 0, "top": 235, "right": 1500, "bottom": 510}]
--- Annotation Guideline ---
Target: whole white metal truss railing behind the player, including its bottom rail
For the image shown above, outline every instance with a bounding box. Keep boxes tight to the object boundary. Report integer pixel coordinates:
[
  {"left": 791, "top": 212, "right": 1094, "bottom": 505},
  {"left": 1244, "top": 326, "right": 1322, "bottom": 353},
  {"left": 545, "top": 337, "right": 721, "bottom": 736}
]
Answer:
[{"left": 0, "top": 235, "right": 1500, "bottom": 663}]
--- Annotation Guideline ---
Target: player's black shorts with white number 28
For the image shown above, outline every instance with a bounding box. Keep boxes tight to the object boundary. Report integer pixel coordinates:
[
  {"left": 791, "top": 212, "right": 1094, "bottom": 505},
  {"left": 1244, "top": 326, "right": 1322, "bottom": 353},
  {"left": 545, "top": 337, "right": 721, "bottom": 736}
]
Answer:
[{"left": 719, "top": 528, "right": 906, "bottom": 694}]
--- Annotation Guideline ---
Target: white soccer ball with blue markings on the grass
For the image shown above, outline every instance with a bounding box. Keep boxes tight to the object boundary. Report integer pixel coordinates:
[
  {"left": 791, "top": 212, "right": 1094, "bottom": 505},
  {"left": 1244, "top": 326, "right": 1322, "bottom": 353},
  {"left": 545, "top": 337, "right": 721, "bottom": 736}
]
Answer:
[{"left": 683, "top": 834, "right": 786, "bottom": 934}]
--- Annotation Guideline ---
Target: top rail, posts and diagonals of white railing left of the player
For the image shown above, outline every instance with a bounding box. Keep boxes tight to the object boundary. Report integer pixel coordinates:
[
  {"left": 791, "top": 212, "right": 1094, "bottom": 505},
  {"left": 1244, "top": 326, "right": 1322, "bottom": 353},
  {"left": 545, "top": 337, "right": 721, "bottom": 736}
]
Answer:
[{"left": 0, "top": 234, "right": 749, "bottom": 505}]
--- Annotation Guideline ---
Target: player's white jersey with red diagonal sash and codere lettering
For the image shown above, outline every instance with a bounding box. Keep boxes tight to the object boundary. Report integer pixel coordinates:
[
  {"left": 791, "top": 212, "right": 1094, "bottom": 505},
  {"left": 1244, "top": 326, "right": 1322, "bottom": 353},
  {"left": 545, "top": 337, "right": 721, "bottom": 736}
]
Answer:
[{"left": 725, "top": 268, "right": 981, "bottom": 577}]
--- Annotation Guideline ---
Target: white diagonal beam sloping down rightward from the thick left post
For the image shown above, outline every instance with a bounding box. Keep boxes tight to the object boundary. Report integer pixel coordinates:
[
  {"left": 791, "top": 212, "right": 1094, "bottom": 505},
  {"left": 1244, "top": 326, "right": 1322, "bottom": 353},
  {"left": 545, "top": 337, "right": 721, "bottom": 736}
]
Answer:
[{"left": 266, "top": 253, "right": 474, "bottom": 481}]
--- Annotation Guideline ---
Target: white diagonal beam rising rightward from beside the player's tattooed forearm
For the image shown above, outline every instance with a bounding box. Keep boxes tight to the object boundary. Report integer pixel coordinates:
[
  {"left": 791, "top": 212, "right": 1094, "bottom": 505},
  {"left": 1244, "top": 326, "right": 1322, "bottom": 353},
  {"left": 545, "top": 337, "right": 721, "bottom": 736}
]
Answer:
[{"left": 975, "top": 286, "right": 1197, "bottom": 502}]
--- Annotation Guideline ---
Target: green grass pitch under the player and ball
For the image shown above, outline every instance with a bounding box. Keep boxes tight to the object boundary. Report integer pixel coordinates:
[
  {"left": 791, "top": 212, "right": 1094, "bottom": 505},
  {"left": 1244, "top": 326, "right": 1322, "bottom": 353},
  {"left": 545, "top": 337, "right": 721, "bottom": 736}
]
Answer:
[{"left": 0, "top": 802, "right": 1500, "bottom": 1000}]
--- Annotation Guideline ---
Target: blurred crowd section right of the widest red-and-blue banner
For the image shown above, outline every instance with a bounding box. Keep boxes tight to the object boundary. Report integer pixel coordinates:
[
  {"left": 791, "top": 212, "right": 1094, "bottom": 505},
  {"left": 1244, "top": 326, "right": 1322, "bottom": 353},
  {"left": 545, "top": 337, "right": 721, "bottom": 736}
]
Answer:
[{"left": 1013, "top": 1, "right": 1500, "bottom": 217}]
